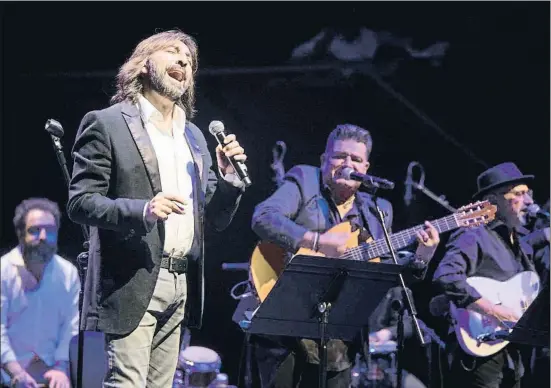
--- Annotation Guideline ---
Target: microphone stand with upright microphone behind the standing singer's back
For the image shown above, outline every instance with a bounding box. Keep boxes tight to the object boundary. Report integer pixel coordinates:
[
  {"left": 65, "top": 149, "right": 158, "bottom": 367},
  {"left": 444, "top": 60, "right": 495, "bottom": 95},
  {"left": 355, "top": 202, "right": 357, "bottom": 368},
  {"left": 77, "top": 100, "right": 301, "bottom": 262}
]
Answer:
[{"left": 46, "top": 123, "right": 90, "bottom": 388}]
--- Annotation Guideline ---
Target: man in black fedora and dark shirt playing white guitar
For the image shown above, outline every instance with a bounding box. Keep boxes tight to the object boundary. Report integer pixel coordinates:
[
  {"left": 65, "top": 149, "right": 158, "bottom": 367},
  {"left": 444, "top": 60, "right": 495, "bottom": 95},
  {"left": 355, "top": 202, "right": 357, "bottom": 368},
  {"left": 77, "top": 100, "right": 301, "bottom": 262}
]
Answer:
[{"left": 433, "top": 162, "right": 549, "bottom": 388}]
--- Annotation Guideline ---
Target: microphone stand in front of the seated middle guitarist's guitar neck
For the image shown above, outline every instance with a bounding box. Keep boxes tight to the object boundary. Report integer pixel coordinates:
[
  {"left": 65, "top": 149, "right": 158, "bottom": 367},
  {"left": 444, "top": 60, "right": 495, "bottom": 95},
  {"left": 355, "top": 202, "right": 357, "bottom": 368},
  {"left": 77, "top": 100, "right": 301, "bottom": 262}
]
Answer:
[{"left": 372, "top": 188, "right": 425, "bottom": 388}]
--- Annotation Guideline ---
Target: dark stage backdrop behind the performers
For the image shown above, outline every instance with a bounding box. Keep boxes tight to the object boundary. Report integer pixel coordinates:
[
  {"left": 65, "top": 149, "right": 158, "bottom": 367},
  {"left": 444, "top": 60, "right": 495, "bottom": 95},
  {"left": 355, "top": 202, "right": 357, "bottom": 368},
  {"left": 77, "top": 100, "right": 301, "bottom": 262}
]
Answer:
[{"left": 0, "top": 2, "right": 550, "bottom": 382}]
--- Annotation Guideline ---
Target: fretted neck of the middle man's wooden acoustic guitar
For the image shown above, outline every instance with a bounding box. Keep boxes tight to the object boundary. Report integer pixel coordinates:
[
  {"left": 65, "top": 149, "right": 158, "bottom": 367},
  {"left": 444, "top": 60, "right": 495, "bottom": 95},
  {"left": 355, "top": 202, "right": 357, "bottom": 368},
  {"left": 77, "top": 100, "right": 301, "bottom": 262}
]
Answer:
[{"left": 342, "top": 213, "right": 459, "bottom": 260}]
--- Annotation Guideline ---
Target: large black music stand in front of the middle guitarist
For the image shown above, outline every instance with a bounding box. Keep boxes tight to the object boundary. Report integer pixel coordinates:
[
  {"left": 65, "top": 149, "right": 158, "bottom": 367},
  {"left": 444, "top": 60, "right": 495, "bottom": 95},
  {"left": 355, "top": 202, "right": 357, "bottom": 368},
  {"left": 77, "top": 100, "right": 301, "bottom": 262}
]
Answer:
[{"left": 242, "top": 255, "right": 407, "bottom": 388}]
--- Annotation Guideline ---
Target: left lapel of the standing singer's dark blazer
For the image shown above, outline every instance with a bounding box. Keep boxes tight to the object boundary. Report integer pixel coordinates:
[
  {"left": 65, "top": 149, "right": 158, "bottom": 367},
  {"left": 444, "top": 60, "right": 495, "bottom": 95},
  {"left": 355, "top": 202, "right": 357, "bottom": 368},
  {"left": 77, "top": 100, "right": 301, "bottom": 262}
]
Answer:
[{"left": 122, "top": 102, "right": 162, "bottom": 195}]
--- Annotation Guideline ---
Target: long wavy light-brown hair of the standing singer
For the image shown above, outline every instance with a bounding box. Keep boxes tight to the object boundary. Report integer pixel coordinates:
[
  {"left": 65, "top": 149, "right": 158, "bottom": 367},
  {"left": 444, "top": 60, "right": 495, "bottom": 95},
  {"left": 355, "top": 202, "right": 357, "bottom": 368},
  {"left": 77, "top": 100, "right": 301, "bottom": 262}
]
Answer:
[{"left": 111, "top": 30, "right": 199, "bottom": 118}]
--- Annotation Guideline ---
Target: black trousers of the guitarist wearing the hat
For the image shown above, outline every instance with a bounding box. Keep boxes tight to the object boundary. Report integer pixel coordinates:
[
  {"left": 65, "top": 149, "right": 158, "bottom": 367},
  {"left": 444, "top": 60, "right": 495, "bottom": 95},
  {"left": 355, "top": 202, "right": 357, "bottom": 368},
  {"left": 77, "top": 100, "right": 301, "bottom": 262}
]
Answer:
[{"left": 444, "top": 349, "right": 532, "bottom": 388}]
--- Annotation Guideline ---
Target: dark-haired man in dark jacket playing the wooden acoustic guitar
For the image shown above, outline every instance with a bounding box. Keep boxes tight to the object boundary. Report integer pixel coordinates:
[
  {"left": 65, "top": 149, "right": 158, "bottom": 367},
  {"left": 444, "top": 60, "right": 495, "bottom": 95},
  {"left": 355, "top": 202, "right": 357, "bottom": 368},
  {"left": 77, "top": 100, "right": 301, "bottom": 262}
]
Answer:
[{"left": 252, "top": 124, "right": 439, "bottom": 388}]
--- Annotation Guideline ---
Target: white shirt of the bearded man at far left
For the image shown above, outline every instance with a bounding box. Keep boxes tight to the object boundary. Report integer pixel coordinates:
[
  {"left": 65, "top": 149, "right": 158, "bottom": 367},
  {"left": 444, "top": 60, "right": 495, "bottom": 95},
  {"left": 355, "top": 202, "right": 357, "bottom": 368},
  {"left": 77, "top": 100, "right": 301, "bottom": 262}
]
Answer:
[{"left": 0, "top": 247, "right": 80, "bottom": 381}]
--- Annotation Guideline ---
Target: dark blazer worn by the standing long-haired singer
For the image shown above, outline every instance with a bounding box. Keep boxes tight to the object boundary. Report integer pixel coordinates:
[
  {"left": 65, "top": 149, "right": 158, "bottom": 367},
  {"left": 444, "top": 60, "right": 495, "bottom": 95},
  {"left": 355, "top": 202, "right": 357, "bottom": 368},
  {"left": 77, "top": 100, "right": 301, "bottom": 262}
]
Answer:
[{"left": 67, "top": 102, "right": 243, "bottom": 335}]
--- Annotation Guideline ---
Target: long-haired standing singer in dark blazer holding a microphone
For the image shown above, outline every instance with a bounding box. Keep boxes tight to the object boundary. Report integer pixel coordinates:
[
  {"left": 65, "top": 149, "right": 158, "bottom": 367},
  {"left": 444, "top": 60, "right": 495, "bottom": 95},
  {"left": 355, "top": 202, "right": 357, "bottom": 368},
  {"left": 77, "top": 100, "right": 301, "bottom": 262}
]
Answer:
[{"left": 67, "top": 31, "right": 246, "bottom": 388}]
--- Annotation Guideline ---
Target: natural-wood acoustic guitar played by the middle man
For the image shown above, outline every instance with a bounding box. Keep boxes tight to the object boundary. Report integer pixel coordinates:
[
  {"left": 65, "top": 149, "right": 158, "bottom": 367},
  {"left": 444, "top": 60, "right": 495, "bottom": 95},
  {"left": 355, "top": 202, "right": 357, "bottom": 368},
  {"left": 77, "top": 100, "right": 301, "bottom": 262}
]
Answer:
[{"left": 249, "top": 201, "right": 497, "bottom": 302}]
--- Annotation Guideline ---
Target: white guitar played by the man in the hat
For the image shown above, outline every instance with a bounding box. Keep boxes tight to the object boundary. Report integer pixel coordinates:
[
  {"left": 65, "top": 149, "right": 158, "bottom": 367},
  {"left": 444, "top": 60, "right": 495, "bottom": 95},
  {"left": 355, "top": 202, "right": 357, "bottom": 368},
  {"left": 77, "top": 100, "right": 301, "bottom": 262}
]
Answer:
[{"left": 450, "top": 271, "right": 540, "bottom": 357}]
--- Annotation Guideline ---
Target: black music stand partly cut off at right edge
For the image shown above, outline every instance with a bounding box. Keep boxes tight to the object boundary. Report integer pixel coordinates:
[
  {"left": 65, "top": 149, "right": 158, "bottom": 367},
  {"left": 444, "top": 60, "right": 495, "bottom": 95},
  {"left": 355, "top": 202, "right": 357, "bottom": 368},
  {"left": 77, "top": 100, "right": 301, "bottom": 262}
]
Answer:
[{"left": 507, "top": 283, "right": 549, "bottom": 347}]
